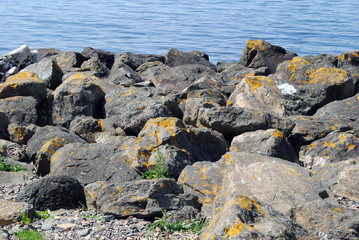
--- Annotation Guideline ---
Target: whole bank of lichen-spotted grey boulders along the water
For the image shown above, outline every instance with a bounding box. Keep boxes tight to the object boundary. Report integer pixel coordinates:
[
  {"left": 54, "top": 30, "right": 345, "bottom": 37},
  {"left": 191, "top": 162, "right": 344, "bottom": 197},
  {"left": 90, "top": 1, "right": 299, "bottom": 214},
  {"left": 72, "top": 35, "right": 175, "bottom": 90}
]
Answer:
[{"left": 0, "top": 40, "right": 359, "bottom": 239}]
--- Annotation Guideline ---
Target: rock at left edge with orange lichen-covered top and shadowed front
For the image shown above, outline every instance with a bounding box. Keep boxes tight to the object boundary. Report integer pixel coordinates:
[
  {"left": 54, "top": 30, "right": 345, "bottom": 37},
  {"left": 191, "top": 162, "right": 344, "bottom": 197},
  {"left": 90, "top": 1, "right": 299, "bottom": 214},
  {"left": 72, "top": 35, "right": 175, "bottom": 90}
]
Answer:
[{"left": 0, "top": 72, "right": 47, "bottom": 100}]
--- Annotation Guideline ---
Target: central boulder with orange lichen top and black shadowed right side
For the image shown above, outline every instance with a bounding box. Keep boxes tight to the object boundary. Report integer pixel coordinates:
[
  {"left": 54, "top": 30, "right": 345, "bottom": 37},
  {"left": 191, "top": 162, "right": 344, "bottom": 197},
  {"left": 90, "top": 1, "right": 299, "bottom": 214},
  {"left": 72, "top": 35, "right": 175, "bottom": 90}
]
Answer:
[{"left": 122, "top": 118, "right": 226, "bottom": 175}]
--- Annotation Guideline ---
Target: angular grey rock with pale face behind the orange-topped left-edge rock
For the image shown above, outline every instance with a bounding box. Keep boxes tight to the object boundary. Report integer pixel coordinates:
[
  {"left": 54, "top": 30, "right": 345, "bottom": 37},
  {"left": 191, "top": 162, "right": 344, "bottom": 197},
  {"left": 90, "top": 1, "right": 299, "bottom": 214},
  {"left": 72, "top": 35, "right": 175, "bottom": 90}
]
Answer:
[{"left": 21, "top": 59, "right": 64, "bottom": 90}]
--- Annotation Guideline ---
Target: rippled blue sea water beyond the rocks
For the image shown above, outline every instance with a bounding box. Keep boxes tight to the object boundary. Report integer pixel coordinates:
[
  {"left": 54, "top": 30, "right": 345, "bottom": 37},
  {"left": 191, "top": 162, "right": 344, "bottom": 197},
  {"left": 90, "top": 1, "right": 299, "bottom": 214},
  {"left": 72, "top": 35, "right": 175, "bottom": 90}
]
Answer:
[{"left": 0, "top": 0, "right": 359, "bottom": 63}]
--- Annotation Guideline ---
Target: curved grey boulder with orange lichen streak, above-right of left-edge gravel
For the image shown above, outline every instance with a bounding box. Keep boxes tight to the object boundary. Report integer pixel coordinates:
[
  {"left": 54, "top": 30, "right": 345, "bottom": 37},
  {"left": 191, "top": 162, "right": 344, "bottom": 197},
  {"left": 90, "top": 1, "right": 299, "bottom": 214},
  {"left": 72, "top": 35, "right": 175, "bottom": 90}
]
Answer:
[{"left": 26, "top": 126, "right": 86, "bottom": 176}]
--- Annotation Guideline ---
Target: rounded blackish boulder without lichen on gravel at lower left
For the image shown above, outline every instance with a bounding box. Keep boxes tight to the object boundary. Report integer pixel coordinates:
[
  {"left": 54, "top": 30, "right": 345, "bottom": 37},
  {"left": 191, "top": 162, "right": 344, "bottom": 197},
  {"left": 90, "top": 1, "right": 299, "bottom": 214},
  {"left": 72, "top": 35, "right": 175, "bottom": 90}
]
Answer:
[{"left": 16, "top": 175, "right": 85, "bottom": 211}]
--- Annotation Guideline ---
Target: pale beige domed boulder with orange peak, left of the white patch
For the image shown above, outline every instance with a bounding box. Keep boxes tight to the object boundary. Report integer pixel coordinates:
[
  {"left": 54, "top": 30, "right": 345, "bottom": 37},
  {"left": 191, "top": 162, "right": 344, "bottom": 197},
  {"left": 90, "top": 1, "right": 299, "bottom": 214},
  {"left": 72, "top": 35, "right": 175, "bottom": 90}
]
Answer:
[{"left": 227, "top": 76, "right": 284, "bottom": 116}]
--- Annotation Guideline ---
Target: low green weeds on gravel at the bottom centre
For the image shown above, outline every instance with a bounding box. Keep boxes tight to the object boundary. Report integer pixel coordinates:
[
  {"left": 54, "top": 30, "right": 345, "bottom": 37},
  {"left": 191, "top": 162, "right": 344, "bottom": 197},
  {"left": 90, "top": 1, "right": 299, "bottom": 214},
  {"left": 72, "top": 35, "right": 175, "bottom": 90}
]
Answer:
[{"left": 148, "top": 210, "right": 207, "bottom": 234}]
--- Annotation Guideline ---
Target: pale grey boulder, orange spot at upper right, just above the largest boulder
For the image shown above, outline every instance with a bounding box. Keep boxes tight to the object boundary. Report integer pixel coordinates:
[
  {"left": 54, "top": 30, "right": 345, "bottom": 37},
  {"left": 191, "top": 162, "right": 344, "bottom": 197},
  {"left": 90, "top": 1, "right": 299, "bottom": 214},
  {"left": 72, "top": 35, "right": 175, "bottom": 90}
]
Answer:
[{"left": 230, "top": 129, "right": 299, "bottom": 163}]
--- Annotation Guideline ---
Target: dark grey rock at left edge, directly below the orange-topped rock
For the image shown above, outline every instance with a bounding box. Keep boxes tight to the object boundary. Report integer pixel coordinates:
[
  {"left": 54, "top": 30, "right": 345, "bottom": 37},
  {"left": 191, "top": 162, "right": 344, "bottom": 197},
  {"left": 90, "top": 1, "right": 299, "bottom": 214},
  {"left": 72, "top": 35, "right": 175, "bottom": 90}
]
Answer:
[{"left": 0, "top": 96, "right": 38, "bottom": 125}]
